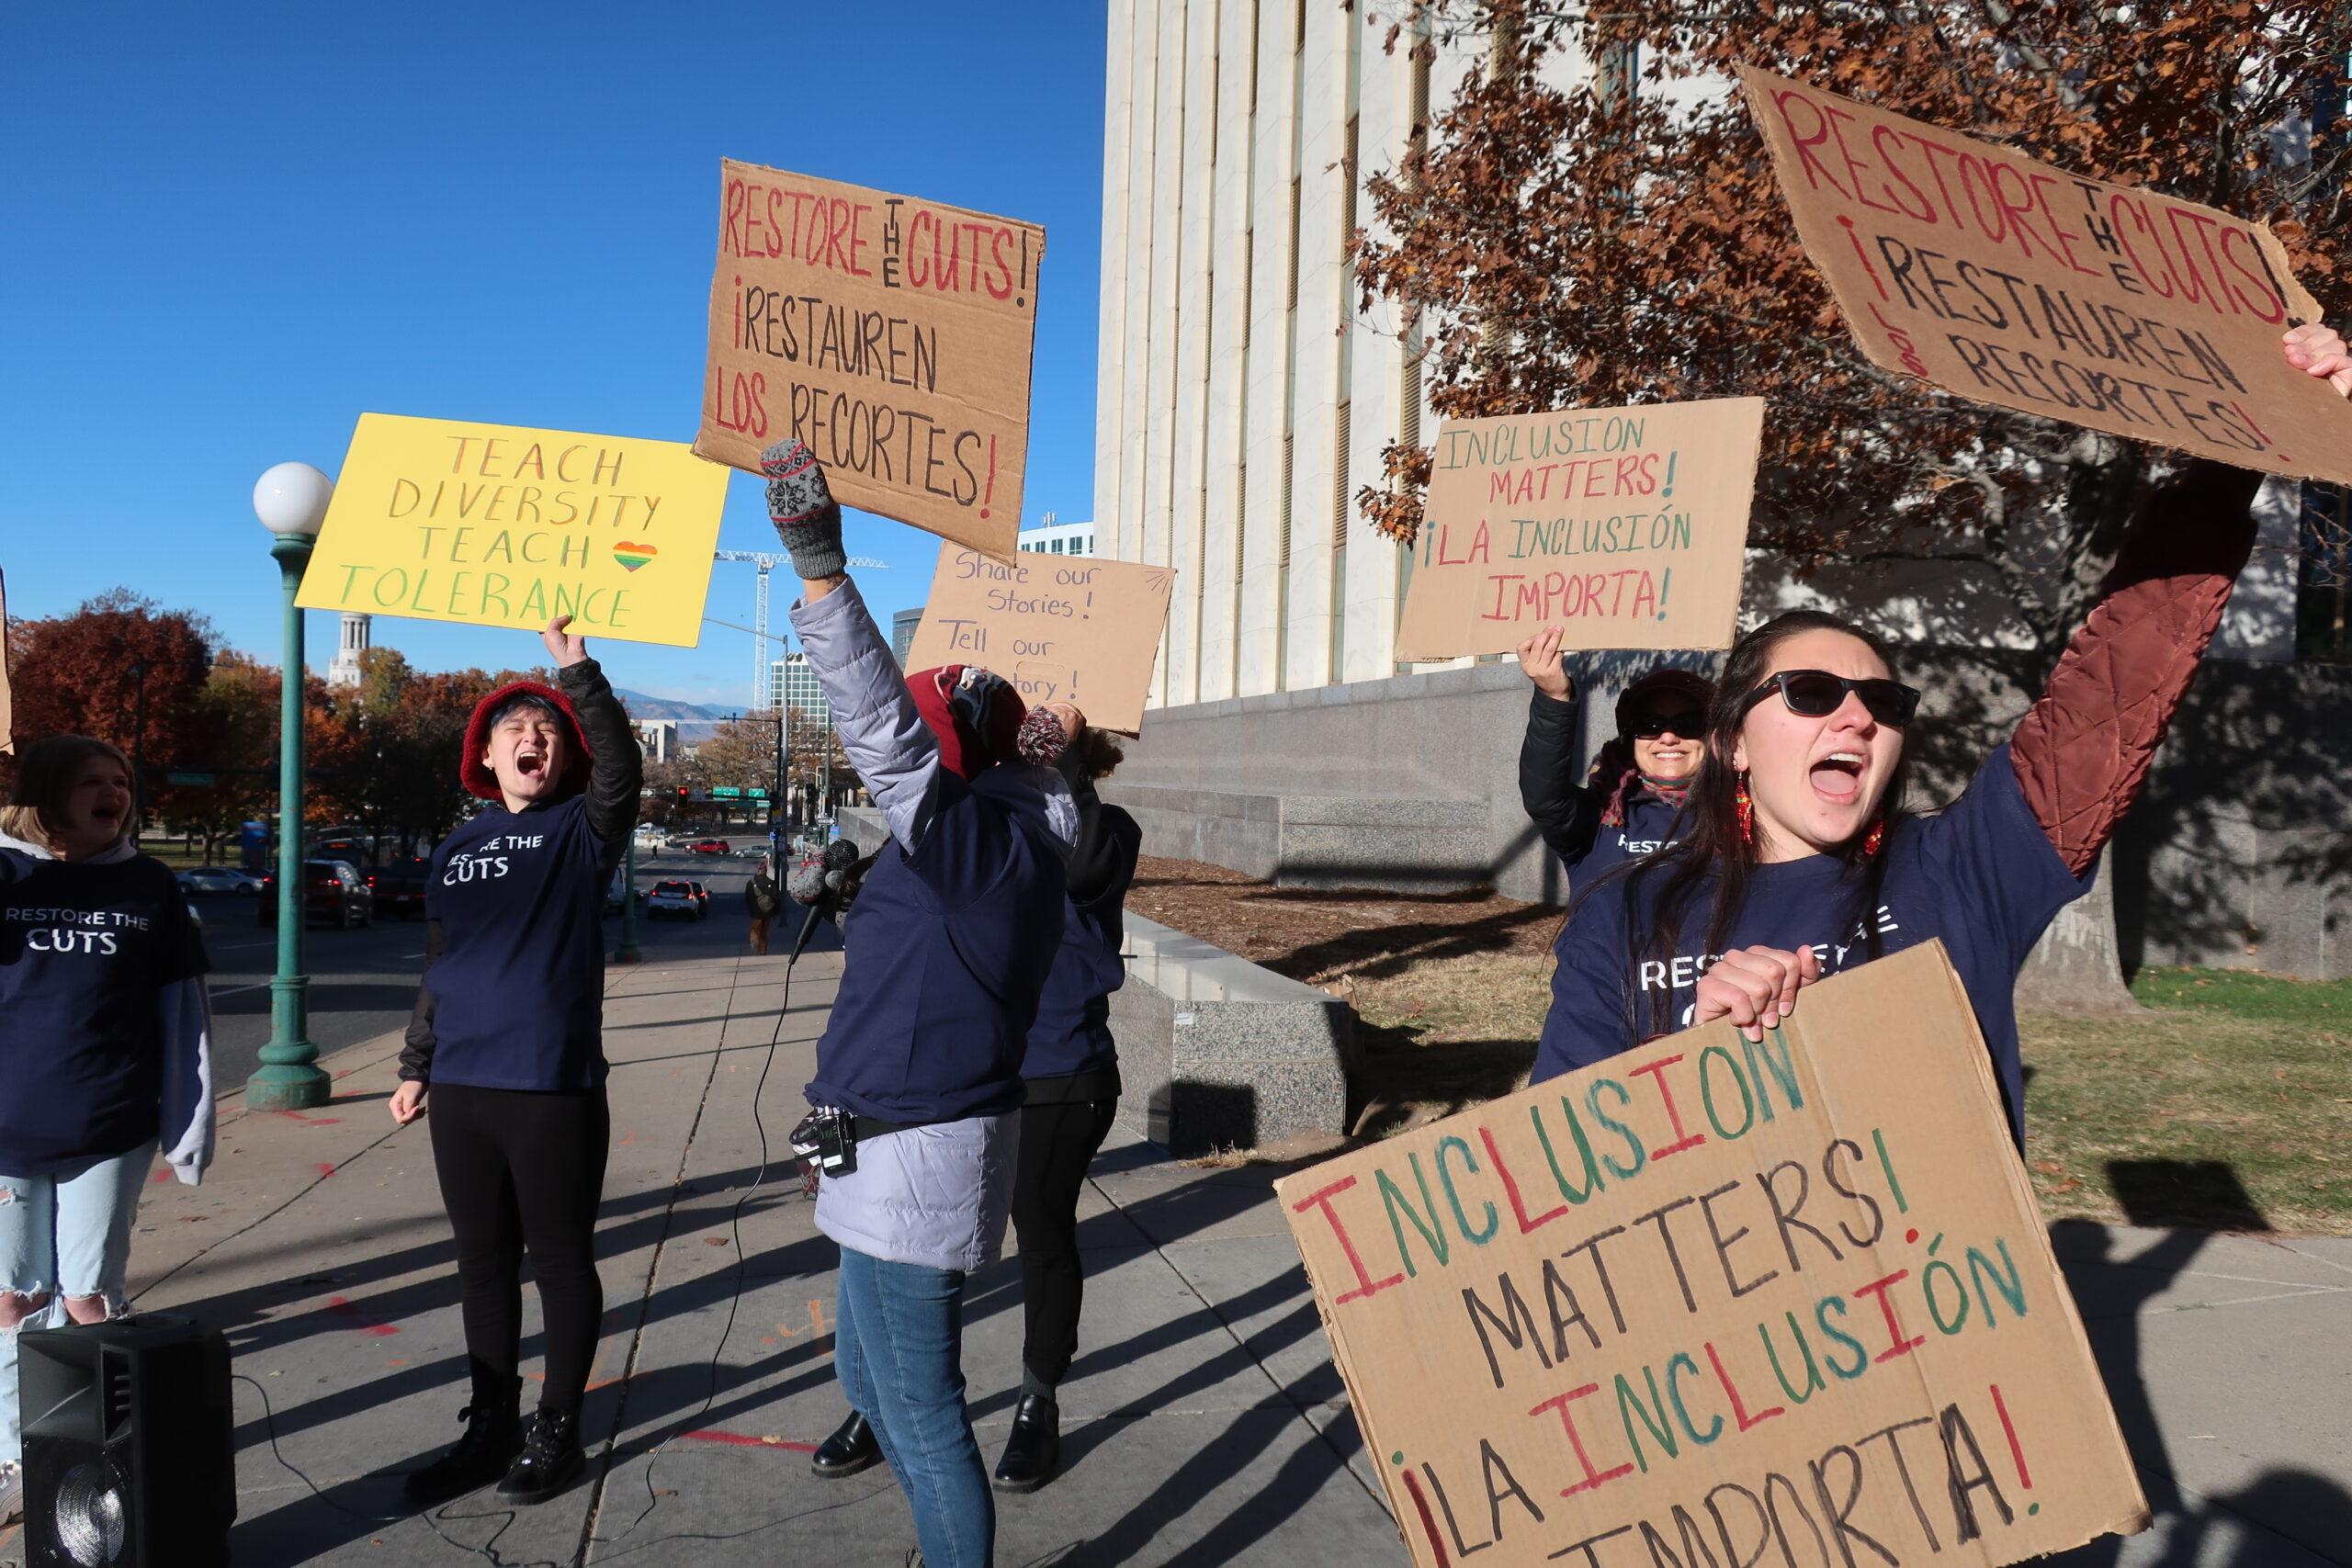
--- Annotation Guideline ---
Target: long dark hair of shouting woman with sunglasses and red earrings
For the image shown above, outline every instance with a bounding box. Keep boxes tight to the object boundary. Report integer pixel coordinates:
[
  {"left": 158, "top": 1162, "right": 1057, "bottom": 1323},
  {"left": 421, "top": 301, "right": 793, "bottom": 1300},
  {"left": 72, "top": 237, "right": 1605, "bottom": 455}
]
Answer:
[{"left": 1625, "top": 609, "right": 1910, "bottom": 1037}]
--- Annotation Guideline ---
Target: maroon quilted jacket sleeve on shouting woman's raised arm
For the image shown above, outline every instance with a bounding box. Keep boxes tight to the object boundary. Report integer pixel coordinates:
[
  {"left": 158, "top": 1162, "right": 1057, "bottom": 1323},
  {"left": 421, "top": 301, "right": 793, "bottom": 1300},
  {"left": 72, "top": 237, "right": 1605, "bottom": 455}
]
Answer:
[{"left": 2008, "top": 461, "right": 2263, "bottom": 877}]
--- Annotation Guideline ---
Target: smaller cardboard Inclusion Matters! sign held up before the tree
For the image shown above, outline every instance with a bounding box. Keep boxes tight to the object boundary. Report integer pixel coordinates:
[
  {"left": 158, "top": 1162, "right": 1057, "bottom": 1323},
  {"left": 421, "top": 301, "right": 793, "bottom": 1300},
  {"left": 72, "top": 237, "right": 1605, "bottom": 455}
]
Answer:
[{"left": 1397, "top": 398, "right": 1764, "bottom": 659}]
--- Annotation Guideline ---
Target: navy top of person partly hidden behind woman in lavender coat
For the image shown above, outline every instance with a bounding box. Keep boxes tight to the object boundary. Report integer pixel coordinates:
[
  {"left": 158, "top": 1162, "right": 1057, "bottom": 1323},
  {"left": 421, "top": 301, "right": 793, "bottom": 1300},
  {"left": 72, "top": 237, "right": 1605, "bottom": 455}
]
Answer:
[{"left": 1021, "top": 745, "right": 1143, "bottom": 1105}]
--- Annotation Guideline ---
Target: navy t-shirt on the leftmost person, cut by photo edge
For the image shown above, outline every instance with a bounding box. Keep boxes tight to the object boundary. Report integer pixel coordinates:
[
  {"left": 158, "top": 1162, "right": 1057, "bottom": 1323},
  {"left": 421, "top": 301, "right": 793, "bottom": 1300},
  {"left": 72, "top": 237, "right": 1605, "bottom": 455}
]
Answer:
[{"left": 0, "top": 849, "right": 205, "bottom": 1178}]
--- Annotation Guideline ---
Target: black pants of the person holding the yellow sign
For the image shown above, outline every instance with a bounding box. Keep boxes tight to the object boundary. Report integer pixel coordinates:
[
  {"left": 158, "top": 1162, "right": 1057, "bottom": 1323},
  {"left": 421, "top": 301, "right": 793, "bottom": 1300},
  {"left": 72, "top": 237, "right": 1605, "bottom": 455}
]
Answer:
[{"left": 425, "top": 1084, "right": 612, "bottom": 1416}]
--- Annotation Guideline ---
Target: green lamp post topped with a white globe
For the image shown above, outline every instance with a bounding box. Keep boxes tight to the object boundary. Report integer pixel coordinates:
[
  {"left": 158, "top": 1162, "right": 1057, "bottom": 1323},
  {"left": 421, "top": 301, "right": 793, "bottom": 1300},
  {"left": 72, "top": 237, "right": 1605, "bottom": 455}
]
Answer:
[{"left": 244, "top": 463, "right": 334, "bottom": 1110}]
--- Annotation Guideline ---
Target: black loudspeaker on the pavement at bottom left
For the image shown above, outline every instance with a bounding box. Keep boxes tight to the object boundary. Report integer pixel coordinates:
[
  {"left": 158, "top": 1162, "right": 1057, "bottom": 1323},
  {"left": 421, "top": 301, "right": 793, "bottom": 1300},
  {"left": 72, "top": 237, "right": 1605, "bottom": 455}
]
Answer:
[{"left": 17, "top": 1312, "right": 238, "bottom": 1568}]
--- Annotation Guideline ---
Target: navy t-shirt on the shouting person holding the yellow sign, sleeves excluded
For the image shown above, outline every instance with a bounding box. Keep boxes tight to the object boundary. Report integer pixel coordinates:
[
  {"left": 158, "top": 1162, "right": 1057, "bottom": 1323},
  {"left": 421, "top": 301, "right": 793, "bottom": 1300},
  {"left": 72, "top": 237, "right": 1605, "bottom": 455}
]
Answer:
[{"left": 424, "top": 795, "right": 621, "bottom": 1090}]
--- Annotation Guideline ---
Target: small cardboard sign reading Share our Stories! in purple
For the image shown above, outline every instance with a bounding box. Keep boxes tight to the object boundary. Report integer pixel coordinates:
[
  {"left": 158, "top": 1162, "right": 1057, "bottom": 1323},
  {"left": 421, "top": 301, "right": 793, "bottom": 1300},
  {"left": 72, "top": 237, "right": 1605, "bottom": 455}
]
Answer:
[{"left": 906, "top": 546, "right": 1176, "bottom": 736}]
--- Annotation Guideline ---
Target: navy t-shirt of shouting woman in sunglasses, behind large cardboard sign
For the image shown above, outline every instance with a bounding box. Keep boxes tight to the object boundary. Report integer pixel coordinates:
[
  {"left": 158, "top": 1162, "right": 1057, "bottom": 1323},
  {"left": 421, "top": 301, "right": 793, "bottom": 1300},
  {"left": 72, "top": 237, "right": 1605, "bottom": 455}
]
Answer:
[{"left": 1533, "top": 745, "right": 2096, "bottom": 1143}]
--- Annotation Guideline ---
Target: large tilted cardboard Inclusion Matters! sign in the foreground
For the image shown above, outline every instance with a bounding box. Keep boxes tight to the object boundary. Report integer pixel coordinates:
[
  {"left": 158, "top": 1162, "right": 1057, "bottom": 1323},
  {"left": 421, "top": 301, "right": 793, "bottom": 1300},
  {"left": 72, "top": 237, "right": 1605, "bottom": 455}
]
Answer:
[{"left": 1277, "top": 942, "right": 2147, "bottom": 1568}]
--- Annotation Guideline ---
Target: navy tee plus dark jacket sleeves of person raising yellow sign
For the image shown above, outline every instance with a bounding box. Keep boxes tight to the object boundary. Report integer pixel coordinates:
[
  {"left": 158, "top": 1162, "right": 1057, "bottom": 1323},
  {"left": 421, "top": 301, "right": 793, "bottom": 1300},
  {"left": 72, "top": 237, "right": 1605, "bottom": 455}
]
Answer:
[{"left": 400, "top": 659, "right": 644, "bottom": 1090}]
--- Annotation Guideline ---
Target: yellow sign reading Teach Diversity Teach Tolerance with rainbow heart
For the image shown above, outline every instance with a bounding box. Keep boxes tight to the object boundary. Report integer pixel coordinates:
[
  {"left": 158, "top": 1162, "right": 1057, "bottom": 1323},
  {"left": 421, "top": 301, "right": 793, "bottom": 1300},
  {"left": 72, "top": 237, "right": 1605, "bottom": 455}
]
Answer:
[{"left": 297, "top": 413, "right": 727, "bottom": 647}]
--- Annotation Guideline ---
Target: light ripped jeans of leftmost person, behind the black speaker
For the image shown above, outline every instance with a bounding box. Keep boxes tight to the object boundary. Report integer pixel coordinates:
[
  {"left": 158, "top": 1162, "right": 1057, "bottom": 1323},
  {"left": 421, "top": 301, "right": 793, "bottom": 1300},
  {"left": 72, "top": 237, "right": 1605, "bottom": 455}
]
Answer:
[{"left": 0, "top": 1143, "right": 155, "bottom": 1464}]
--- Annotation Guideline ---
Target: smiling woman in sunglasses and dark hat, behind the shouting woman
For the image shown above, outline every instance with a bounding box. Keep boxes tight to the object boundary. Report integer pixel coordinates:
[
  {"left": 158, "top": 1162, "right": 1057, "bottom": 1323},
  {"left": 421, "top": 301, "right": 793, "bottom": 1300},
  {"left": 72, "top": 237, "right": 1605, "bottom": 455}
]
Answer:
[{"left": 1520, "top": 626, "right": 1714, "bottom": 891}]
